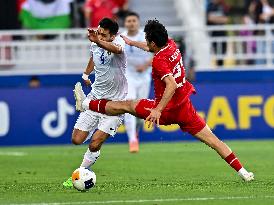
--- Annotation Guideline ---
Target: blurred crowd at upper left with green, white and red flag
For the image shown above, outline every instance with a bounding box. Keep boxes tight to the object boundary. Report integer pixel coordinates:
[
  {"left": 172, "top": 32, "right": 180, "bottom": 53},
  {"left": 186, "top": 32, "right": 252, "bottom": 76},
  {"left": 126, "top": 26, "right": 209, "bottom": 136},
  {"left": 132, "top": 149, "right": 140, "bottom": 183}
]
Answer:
[{"left": 0, "top": 0, "right": 128, "bottom": 30}]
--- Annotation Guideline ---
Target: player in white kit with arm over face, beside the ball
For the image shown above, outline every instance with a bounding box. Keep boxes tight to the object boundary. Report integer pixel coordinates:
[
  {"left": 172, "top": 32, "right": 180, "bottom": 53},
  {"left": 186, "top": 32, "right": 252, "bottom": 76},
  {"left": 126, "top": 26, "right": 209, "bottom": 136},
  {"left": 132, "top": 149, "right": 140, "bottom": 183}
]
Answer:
[{"left": 63, "top": 18, "right": 127, "bottom": 187}]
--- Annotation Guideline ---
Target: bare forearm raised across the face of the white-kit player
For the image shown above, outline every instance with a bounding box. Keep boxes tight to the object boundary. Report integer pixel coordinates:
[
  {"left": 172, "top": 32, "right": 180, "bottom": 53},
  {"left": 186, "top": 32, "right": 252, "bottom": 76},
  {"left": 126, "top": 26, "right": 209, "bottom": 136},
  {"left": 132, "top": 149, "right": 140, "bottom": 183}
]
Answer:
[{"left": 88, "top": 28, "right": 123, "bottom": 54}]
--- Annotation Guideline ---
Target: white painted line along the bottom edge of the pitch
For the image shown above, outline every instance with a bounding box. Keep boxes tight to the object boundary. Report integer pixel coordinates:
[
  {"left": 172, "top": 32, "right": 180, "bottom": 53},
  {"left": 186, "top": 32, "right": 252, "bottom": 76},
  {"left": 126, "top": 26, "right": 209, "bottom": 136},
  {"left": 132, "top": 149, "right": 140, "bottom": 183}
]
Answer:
[{"left": 5, "top": 196, "right": 274, "bottom": 205}]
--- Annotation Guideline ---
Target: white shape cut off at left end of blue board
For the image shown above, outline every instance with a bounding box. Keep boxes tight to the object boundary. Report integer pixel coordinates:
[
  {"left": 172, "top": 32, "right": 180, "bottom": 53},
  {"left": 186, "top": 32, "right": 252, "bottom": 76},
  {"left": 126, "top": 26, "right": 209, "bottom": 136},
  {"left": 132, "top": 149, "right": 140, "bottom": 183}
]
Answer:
[{"left": 0, "top": 102, "right": 10, "bottom": 137}]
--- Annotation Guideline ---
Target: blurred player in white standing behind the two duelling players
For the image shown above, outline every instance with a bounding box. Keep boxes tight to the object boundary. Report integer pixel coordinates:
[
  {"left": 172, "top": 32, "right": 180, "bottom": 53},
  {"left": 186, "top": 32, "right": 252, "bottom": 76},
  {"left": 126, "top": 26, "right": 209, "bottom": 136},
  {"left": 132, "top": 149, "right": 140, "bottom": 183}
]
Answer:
[{"left": 122, "top": 12, "right": 152, "bottom": 153}]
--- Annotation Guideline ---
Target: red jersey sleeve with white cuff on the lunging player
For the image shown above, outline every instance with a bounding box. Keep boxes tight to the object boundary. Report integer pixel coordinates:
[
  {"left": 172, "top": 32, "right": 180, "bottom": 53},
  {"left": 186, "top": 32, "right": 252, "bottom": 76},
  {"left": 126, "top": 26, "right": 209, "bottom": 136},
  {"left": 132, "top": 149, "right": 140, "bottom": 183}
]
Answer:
[{"left": 152, "top": 59, "right": 172, "bottom": 80}]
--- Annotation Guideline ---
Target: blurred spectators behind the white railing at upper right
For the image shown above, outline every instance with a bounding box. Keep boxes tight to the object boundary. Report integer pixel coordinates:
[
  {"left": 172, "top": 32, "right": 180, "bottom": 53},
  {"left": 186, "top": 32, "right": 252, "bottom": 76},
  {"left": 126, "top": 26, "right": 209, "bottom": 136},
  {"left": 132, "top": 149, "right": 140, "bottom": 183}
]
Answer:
[{"left": 206, "top": 0, "right": 274, "bottom": 66}]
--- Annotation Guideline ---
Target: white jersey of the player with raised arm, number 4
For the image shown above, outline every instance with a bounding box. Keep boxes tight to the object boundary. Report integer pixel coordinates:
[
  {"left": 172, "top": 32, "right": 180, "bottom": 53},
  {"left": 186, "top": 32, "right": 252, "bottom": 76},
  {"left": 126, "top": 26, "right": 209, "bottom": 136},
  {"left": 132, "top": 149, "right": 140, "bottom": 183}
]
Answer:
[{"left": 89, "top": 36, "right": 128, "bottom": 100}]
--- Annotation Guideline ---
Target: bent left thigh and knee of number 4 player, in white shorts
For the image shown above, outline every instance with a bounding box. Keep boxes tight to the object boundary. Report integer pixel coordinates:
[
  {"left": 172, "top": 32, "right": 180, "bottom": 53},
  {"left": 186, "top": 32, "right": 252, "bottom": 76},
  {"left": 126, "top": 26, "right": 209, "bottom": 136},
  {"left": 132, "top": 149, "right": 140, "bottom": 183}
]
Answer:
[{"left": 72, "top": 110, "right": 99, "bottom": 144}]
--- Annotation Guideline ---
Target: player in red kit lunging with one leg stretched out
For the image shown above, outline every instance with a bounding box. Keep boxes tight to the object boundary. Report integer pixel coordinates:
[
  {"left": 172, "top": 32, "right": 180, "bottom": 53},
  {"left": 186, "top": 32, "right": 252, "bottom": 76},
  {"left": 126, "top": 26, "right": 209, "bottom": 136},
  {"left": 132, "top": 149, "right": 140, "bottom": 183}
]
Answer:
[{"left": 75, "top": 20, "right": 254, "bottom": 181}]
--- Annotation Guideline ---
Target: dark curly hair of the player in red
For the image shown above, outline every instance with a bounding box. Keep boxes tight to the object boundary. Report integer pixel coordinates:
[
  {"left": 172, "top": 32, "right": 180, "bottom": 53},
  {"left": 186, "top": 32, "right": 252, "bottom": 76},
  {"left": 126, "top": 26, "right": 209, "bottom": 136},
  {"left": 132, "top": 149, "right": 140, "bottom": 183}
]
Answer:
[{"left": 144, "top": 19, "right": 168, "bottom": 47}]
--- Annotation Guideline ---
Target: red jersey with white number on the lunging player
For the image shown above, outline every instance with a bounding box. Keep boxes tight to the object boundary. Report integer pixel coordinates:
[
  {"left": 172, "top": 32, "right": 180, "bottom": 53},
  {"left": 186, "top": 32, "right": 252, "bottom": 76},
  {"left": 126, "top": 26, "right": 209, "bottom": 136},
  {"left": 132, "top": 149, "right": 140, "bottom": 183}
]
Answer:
[{"left": 152, "top": 39, "right": 195, "bottom": 110}]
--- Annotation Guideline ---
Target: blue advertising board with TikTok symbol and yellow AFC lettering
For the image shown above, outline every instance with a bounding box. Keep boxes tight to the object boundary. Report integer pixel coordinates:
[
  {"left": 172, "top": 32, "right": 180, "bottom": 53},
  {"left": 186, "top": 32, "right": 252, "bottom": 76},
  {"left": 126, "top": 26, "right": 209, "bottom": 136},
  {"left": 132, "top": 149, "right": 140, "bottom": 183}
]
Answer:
[{"left": 0, "top": 79, "right": 274, "bottom": 145}]
